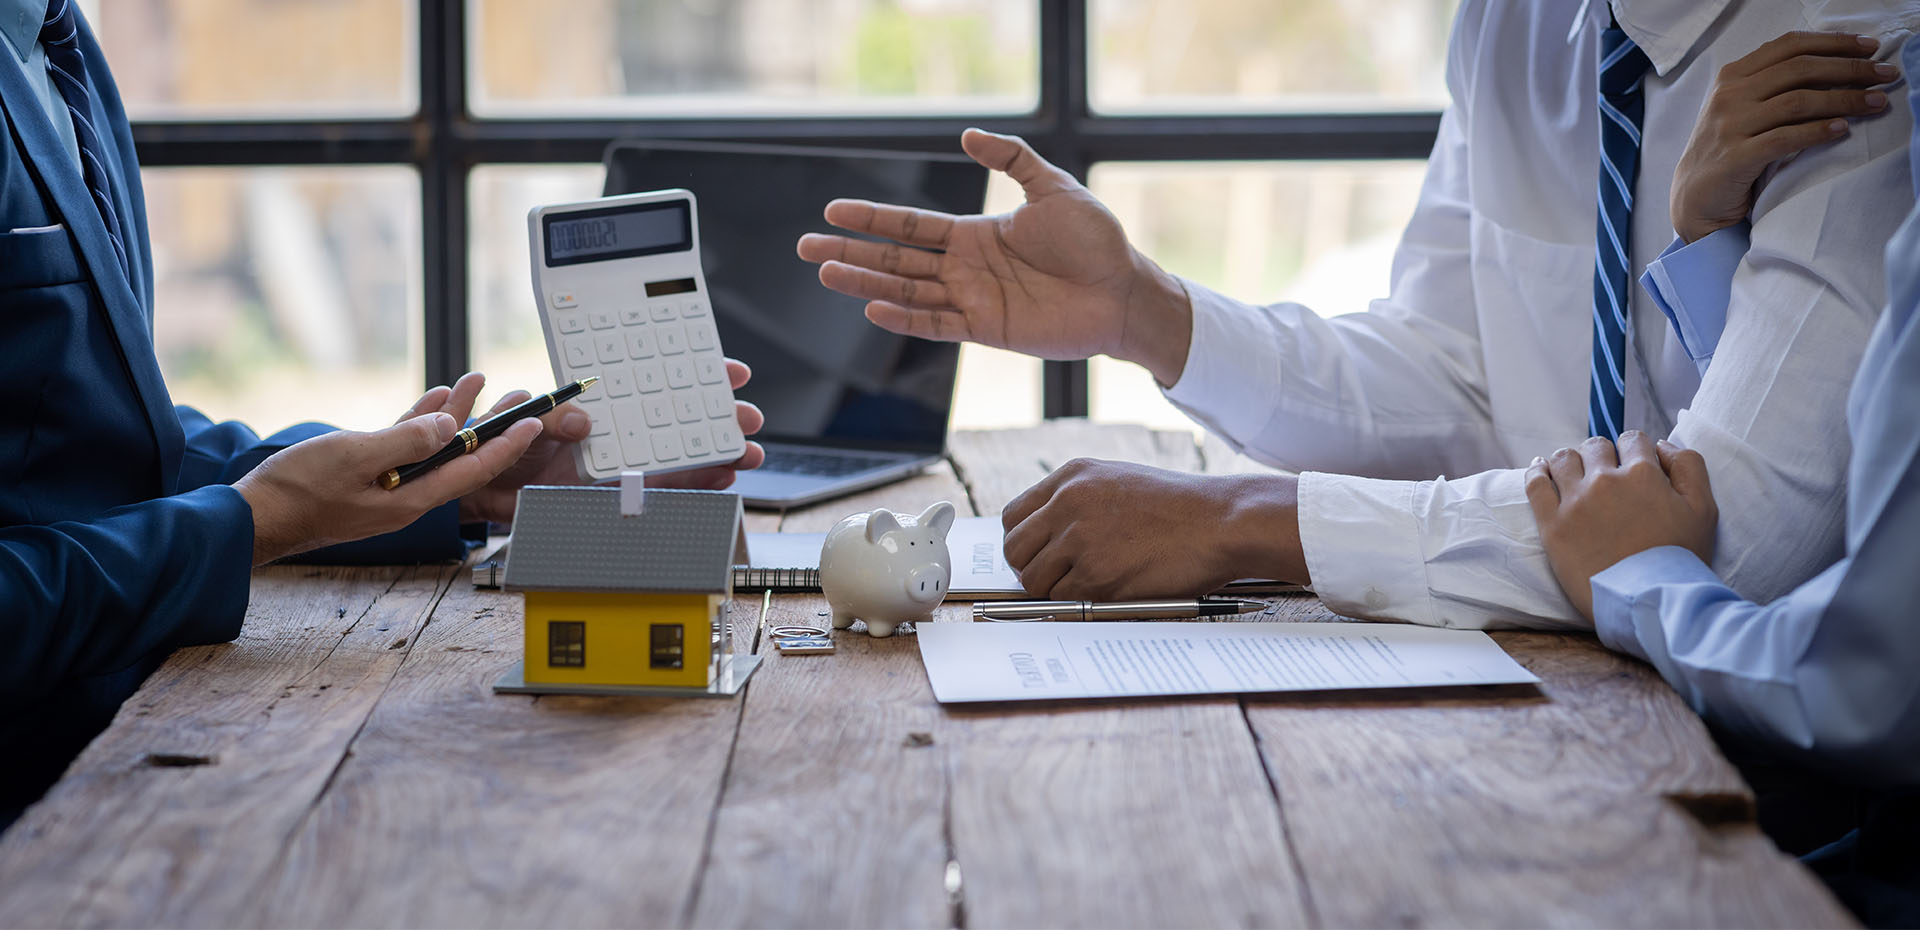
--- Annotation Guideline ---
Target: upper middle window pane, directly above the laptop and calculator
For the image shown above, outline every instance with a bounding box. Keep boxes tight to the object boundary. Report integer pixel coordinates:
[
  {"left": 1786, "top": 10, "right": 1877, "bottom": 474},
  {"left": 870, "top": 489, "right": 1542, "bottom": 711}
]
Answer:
[{"left": 468, "top": 0, "right": 1039, "bottom": 119}]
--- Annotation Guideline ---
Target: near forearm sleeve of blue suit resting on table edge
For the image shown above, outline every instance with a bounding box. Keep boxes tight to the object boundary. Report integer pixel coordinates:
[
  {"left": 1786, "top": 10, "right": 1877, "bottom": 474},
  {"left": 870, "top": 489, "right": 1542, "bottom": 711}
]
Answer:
[{"left": 0, "top": 486, "right": 253, "bottom": 705}]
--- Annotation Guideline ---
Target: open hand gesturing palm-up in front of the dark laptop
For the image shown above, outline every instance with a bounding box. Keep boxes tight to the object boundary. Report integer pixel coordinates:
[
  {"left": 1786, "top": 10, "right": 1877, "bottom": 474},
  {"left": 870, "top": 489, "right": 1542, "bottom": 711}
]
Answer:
[{"left": 797, "top": 129, "right": 1190, "bottom": 384}]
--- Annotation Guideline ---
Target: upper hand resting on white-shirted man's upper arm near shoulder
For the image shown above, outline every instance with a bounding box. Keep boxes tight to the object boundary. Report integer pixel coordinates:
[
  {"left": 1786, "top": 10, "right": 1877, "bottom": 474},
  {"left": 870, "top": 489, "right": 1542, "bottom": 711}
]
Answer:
[{"left": 1670, "top": 33, "right": 1899, "bottom": 242}]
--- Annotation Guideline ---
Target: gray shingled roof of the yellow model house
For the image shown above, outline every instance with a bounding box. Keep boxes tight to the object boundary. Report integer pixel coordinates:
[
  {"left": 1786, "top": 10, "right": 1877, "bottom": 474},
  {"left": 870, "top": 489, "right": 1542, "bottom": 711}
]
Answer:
[{"left": 505, "top": 488, "right": 745, "bottom": 594}]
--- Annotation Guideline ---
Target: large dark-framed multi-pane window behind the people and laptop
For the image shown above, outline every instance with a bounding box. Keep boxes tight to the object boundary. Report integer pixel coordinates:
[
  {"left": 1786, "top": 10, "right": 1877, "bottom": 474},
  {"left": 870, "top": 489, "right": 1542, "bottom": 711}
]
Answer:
[{"left": 105, "top": 0, "right": 1453, "bottom": 428}]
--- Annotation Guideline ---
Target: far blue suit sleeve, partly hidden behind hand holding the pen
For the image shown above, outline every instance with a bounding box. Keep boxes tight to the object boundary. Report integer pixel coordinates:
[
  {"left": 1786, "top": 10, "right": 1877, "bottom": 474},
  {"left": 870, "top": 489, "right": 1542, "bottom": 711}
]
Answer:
[{"left": 175, "top": 407, "right": 467, "bottom": 565}]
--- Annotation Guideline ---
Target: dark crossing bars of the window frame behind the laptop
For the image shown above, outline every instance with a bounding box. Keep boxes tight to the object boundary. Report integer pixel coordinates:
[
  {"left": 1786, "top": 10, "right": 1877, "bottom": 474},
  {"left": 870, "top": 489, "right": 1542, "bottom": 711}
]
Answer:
[{"left": 132, "top": 0, "right": 1440, "bottom": 419}]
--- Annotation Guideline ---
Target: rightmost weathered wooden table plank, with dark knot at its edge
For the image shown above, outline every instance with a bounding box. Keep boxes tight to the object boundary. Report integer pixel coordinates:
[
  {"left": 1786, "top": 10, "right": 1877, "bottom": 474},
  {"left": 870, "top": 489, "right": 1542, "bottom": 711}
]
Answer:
[{"left": 1167, "top": 434, "right": 1851, "bottom": 926}]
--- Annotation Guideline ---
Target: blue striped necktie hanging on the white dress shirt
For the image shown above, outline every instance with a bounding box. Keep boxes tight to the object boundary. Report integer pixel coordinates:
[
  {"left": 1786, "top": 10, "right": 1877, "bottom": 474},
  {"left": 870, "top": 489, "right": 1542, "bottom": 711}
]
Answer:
[{"left": 1586, "top": 25, "right": 1653, "bottom": 440}]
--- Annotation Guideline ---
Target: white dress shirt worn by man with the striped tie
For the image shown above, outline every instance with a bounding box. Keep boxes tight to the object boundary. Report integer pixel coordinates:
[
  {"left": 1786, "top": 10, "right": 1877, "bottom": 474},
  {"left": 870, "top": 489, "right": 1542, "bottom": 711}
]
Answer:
[{"left": 1167, "top": 0, "right": 1920, "bottom": 628}]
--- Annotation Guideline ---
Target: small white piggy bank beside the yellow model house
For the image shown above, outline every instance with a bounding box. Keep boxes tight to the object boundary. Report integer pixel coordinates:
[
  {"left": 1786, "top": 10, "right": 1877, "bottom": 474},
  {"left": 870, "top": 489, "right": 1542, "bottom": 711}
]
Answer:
[{"left": 820, "top": 502, "right": 954, "bottom": 636}]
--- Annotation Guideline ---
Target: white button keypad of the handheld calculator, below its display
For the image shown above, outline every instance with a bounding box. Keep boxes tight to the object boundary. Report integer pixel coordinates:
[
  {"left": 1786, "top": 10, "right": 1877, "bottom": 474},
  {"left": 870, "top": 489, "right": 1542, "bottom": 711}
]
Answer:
[{"left": 549, "top": 292, "right": 745, "bottom": 478}]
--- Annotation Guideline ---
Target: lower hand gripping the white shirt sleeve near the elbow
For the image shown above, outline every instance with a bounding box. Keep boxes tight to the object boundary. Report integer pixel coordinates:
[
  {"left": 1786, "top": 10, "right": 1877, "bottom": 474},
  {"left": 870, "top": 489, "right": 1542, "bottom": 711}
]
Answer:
[{"left": 1526, "top": 430, "right": 1720, "bottom": 621}]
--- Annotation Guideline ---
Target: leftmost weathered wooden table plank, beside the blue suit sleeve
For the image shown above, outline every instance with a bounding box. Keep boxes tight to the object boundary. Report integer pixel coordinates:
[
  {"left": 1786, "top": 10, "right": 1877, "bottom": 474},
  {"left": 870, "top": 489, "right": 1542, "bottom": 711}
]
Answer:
[{"left": 0, "top": 567, "right": 453, "bottom": 926}]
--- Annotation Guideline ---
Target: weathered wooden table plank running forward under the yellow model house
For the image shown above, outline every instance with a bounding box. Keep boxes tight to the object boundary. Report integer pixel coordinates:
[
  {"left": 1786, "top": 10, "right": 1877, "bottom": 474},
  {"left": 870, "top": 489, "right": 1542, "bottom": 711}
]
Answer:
[{"left": 236, "top": 564, "right": 756, "bottom": 926}]
